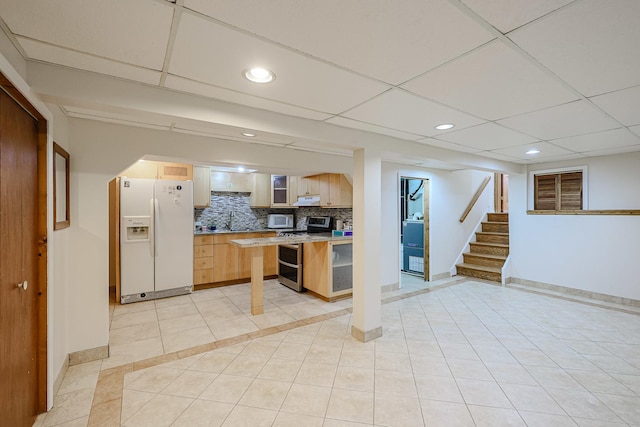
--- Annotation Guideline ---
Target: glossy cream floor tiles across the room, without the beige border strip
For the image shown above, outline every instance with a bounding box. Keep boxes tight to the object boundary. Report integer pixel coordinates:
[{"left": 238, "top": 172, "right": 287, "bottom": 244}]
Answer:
[{"left": 37, "top": 278, "right": 640, "bottom": 427}]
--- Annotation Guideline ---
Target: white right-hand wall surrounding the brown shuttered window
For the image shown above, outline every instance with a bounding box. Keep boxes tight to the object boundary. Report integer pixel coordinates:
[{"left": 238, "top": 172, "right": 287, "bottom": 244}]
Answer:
[{"left": 509, "top": 152, "right": 640, "bottom": 300}]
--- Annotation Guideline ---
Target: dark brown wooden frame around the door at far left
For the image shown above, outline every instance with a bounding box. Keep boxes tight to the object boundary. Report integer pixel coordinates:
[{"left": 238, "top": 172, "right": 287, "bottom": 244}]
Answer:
[{"left": 0, "top": 72, "right": 49, "bottom": 413}]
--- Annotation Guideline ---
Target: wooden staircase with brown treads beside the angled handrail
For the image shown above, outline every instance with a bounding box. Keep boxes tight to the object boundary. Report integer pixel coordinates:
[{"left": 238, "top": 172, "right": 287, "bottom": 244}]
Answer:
[{"left": 456, "top": 213, "right": 509, "bottom": 282}]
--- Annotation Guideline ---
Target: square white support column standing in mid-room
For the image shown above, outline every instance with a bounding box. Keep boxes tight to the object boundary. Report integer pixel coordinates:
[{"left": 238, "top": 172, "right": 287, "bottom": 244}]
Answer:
[{"left": 351, "top": 148, "right": 382, "bottom": 342}]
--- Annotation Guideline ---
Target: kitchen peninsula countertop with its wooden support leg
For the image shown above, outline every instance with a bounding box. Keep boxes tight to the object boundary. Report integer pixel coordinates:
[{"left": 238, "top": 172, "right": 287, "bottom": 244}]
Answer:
[{"left": 230, "top": 235, "right": 352, "bottom": 315}]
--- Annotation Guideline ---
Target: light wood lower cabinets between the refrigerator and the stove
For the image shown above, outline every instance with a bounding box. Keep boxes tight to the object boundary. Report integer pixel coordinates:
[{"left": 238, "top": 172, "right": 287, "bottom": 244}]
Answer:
[{"left": 193, "top": 232, "right": 278, "bottom": 285}]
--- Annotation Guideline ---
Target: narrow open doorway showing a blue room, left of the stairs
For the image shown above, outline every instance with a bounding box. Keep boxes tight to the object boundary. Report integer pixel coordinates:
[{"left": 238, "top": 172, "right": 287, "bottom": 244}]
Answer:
[{"left": 399, "top": 176, "right": 430, "bottom": 281}]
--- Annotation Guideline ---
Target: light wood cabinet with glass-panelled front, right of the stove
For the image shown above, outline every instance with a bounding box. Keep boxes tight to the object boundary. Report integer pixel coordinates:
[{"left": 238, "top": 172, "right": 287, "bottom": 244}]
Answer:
[{"left": 302, "top": 240, "right": 353, "bottom": 301}]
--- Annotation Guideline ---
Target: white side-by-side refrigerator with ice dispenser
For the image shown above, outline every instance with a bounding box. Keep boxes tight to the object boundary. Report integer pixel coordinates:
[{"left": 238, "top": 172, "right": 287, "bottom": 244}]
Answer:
[{"left": 120, "top": 178, "right": 193, "bottom": 304}]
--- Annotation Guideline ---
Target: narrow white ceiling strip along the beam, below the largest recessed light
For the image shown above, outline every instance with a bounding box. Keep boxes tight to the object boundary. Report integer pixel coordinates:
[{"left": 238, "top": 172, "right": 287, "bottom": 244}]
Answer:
[{"left": 164, "top": 74, "right": 331, "bottom": 120}]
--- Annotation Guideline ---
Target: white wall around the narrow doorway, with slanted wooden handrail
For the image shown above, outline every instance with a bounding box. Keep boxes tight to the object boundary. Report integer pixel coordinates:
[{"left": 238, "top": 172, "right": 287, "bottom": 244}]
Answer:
[{"left": 381, "top": 163, "right": 493, "bottom": 286}]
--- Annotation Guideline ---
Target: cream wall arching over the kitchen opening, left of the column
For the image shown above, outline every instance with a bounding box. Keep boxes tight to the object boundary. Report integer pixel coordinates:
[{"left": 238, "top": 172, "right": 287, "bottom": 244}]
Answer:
[{"left": 68, "top": 119, "right": 351, "bottom": 352}]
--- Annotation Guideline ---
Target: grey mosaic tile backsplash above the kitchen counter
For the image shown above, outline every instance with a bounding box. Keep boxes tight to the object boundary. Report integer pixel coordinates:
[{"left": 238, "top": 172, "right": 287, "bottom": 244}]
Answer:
[{"left": 194, "top": 191, "right": 353, "bottom": 230}]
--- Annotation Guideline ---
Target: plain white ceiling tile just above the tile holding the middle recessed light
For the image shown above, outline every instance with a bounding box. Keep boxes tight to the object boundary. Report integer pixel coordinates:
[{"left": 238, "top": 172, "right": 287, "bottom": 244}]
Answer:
[{"left": 402, "top": 41, "right": 577, "bottom": 120}]
